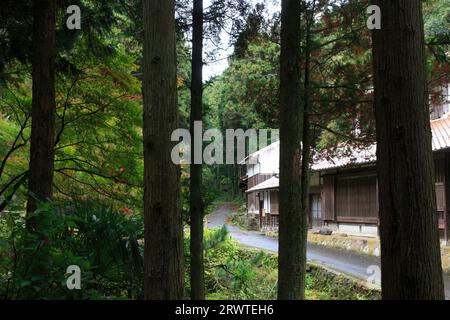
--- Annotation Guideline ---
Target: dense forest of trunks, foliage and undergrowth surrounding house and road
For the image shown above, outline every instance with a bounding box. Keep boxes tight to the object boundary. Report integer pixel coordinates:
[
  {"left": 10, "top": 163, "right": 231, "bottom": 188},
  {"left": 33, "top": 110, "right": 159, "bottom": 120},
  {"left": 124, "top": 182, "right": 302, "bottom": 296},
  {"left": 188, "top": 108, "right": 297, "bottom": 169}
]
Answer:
[{"left": 0, "top": 0, "right": 450, "bottom": 300}]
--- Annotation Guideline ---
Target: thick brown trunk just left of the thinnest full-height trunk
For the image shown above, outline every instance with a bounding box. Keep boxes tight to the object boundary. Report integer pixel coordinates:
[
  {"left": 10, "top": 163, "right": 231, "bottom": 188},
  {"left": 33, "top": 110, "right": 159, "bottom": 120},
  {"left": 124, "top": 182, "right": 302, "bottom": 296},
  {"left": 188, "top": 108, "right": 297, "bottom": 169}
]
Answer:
[{"left": 143, "top": 0, "right": 184, "bottom": 300}]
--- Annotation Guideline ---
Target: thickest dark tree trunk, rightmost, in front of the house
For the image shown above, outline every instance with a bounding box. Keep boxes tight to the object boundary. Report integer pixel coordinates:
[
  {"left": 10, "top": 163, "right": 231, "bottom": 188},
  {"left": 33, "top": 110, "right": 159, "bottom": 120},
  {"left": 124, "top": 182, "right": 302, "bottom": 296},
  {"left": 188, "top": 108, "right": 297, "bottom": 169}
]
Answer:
[{"left": 373, "top": 0, "right": 444, "bottom": 299}]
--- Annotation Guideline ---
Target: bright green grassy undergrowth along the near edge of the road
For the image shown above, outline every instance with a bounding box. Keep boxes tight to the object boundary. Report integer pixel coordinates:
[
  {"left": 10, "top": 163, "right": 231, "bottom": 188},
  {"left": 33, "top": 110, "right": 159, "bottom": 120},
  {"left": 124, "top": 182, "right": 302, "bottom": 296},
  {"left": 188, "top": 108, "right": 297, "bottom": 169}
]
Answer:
[{"left": 185, "top": 226, "right": 380, "bottom": 300}]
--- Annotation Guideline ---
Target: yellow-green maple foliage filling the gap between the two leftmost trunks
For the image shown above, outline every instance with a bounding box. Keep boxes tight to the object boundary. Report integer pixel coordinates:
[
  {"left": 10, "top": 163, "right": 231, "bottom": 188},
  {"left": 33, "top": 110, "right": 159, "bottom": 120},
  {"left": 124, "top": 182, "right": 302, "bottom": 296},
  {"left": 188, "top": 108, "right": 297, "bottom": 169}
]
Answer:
[{"left": 51, "top": 40, "right": 143, "bottom": 207}]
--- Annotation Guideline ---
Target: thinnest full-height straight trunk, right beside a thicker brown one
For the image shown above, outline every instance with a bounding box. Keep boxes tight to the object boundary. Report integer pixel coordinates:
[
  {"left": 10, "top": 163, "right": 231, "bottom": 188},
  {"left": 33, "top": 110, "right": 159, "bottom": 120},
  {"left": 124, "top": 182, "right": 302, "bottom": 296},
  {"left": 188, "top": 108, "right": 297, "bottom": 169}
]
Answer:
[{"left": 190, "top": 0, "right": 205, "bottom": 300}]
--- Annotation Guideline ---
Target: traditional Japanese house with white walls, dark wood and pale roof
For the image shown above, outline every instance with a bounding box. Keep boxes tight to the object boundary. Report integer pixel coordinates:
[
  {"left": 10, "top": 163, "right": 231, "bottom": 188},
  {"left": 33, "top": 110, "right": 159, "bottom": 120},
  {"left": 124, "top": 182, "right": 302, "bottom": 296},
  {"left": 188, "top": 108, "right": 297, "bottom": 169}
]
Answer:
[{"left": 241, "top": 116, "right": 450, "bottom": 241}]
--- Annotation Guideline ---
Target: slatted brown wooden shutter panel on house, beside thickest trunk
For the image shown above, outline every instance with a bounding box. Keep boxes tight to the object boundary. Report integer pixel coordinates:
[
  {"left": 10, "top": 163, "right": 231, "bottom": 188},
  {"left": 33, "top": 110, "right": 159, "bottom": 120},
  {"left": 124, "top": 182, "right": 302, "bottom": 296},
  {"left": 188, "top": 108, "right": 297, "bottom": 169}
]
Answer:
[{"left": 335, "top": 176, "right": 378, "bottom": 223}]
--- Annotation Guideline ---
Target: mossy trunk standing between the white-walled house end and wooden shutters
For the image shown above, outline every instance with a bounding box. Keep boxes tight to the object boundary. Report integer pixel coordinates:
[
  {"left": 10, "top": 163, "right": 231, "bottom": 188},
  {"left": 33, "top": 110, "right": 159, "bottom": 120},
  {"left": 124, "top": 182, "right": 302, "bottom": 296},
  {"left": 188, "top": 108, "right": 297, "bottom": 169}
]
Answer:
[{"left": 278, "top": 0, "right": 308, "bottom": 300}]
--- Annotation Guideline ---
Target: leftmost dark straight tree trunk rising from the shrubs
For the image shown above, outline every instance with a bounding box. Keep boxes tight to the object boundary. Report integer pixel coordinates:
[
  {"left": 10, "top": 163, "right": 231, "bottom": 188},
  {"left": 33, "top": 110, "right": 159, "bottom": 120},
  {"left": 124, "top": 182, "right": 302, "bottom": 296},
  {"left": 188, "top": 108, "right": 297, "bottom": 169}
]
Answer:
[{"left": 27, "top": 0, "right": 56, "bottom": 218}]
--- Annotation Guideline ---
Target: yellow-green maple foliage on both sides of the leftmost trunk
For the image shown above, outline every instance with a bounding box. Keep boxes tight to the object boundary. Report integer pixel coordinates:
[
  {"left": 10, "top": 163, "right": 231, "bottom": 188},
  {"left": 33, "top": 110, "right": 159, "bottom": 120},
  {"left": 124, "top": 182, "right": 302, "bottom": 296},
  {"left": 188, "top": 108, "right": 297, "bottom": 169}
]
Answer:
[{"left": 0, "top": 37, "right": 143, "bottom": 212}]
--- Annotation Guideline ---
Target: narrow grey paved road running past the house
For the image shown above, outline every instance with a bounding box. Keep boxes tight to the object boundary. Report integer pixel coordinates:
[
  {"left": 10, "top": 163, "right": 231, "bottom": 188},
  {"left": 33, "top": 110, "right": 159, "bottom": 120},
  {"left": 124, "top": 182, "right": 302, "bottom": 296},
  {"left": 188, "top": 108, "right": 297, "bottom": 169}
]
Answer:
[{"left": 208, "top": 204, "right": 450, "bottom": 299}]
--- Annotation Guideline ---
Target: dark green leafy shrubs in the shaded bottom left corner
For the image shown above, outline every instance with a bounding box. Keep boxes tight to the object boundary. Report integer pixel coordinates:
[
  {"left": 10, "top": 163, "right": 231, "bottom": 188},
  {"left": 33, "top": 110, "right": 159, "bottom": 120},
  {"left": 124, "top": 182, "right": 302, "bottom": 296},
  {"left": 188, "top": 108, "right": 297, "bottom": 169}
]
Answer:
[{"left": 0, "top": 203, "right": 143, "bottom": 299}]
